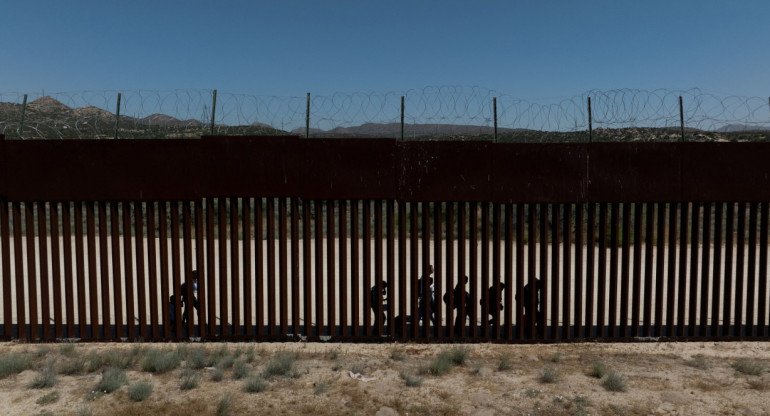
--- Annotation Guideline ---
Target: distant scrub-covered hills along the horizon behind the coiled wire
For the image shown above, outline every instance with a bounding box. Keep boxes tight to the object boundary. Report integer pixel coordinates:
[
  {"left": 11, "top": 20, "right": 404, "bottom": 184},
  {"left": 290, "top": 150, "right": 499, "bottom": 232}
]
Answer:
[{"left": 0, "top": 96, "right": 770, "bottom": 142}]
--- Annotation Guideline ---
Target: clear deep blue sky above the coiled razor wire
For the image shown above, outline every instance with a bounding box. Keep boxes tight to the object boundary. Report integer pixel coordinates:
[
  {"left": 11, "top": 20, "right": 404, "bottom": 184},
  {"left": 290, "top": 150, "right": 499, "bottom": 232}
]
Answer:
[{"left": 0, "top": 0, "right": 770, "bottom": 99}]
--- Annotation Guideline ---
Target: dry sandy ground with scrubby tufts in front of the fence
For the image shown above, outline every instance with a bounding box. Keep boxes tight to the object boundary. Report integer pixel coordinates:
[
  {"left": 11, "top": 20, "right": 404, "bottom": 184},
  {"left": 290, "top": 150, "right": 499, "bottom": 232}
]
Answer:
[{"left": 0, "top": 342, "right": 770, "bottom": 416}]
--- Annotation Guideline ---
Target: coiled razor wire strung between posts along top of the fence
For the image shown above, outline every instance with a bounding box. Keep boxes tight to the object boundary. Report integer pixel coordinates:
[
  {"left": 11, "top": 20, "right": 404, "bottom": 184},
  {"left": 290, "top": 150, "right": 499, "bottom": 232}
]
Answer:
[{"left": 0, "top": 86, "right": 770, "bottom": 141}]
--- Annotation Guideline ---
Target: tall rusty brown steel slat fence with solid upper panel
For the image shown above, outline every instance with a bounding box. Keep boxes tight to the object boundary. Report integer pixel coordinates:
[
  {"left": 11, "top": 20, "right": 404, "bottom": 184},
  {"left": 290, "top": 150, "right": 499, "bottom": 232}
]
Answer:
[{"left": 0, "top": 136, "right": 770, "bottom": 342}]
